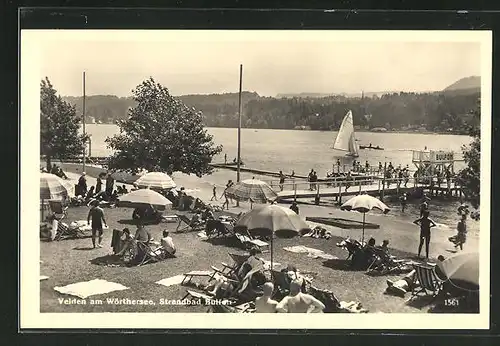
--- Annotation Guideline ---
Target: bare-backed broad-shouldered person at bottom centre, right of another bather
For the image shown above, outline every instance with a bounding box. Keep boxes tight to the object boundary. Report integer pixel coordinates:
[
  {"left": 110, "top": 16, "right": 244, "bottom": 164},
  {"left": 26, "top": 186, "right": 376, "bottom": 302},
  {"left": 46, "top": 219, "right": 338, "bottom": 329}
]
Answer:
[{"left": 276, "top": 280, "right": 325, "bottom": 313}]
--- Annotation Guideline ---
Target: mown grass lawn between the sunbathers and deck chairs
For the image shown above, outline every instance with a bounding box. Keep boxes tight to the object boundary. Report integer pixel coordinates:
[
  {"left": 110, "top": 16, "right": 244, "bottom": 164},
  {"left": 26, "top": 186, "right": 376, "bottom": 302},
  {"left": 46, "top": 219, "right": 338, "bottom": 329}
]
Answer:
[{"left": 40, "top": 207, "right": 438, "bottom": 313}]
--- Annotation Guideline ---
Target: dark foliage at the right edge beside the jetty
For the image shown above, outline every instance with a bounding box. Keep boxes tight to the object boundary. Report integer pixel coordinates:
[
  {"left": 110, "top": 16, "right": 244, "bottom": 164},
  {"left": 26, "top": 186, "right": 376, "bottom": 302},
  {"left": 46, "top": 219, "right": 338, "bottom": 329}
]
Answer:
[{"left": 458, "top": 101, "right": 481, "bottom": 208}]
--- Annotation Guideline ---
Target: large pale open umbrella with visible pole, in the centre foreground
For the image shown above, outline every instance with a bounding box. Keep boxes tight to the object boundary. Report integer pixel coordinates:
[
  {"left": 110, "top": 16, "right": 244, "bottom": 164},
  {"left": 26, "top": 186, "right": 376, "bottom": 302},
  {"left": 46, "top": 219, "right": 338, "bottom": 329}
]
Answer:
[{"left": 235, "top": 204, "right": 311, "bottom": 268}]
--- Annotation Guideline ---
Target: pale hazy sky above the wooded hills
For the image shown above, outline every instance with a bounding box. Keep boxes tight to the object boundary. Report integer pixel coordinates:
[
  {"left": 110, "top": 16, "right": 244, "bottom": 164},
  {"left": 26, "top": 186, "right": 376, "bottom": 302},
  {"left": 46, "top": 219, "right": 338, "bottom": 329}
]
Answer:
[{"left": 30, "top": 30, "right": 481, "bottom": 97}]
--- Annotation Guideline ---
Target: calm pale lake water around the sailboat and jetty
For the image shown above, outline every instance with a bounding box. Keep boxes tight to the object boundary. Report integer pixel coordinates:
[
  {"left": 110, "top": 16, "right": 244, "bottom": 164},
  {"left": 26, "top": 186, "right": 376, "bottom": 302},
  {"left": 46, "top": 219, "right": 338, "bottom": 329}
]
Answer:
[{"left": 80, "top": 124, "right": 479, "bottom": 233}]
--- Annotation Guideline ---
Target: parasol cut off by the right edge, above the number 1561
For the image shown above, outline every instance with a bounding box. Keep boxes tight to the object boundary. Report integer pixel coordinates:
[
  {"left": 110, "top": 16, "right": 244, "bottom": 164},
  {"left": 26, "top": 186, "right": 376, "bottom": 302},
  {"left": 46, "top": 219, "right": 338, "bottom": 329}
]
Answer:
[{"left": 439, "top": 252, "right": 479, "bottom": 291}]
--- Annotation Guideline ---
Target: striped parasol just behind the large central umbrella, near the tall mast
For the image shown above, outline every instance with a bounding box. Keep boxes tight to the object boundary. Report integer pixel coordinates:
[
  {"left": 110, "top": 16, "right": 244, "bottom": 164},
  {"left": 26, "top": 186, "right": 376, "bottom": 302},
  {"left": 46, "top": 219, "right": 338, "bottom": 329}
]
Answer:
[{"left": 226, "top": 179, "right": 278, "bottom": 203}]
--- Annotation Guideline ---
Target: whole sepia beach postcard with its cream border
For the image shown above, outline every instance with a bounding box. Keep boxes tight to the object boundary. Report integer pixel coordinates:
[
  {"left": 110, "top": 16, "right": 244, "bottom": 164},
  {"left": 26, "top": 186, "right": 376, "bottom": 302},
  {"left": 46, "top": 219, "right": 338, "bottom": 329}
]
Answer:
[{"left": 20, "top": 30, "right": 492, "bottom": 329}]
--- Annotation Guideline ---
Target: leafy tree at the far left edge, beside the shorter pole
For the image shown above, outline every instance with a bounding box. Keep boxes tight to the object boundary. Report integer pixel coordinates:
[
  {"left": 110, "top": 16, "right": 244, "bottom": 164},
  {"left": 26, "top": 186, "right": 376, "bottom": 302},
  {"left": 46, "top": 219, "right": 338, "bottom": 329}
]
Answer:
[{"left": 40, "top": 77, "right": 87, "bottom": 170}]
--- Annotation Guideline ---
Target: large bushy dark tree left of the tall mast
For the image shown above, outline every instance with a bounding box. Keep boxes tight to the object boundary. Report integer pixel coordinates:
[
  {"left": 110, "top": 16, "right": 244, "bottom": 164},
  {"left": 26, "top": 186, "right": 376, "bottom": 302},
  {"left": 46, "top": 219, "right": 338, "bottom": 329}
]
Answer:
[{"left": 106, "top": 78, "right": 222, "bottom": 177}]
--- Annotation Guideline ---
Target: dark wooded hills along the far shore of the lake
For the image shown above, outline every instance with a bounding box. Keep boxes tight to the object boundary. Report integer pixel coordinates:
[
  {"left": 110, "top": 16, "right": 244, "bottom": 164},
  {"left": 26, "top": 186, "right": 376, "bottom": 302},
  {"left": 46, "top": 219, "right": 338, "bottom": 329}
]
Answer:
[{"left": 64, "top": 89, "right": 480, "bottom": 134}]
